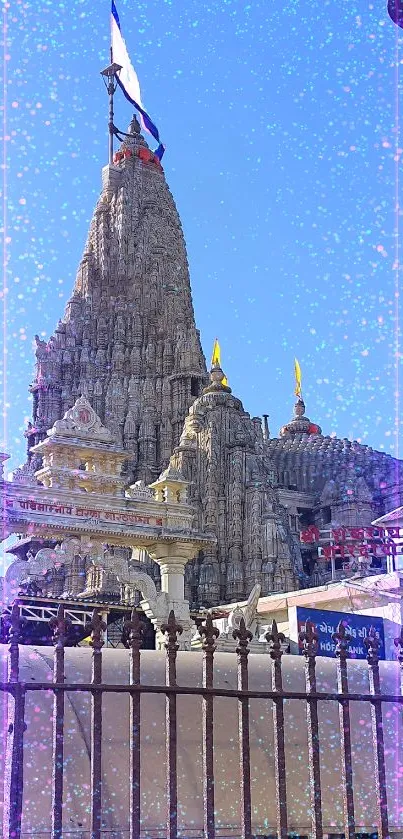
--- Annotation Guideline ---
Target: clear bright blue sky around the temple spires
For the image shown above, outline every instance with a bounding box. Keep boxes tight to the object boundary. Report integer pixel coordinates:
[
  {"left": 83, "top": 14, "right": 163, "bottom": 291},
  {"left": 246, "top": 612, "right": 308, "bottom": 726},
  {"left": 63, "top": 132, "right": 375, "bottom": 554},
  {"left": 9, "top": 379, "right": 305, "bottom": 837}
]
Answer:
[{"left": 2, "top": 0, "right": 403, "bottom": 468}]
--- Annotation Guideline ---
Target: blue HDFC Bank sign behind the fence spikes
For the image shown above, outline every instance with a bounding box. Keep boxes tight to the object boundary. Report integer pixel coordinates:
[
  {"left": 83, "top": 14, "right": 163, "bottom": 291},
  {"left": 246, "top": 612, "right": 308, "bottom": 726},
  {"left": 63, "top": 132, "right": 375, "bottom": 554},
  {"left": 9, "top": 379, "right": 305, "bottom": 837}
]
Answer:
[{"left": 296, "top": 606, "right": 385, "bottom": 659}]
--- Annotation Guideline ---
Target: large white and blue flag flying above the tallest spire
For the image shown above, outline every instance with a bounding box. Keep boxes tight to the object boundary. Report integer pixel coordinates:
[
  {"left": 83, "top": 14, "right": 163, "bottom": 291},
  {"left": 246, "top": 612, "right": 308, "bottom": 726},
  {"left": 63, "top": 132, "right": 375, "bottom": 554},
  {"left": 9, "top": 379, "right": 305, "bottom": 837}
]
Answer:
[{"left": 111, "top": 0, "right": 165, "bottom": 160}]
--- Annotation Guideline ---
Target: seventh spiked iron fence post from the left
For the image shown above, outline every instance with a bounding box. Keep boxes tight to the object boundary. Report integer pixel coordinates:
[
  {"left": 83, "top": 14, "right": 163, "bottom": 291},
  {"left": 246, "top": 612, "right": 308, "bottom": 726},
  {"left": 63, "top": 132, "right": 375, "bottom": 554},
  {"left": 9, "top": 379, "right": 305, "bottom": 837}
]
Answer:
[{"left": 232, "top": 618, "right": 253, "bottom": 839}]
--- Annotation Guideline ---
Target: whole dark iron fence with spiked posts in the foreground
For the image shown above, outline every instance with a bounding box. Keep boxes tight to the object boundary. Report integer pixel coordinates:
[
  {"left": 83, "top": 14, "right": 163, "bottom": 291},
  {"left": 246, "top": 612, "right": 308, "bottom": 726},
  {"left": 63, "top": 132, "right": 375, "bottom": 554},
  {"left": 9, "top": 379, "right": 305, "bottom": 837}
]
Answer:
[{"left": 0, "top": 603, "right": 403, "bottom": 839}]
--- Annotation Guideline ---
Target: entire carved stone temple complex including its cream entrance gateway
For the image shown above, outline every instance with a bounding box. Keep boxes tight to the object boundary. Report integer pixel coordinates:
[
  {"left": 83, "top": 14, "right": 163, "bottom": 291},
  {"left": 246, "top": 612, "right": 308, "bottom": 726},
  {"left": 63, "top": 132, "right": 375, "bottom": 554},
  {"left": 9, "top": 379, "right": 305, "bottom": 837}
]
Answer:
[{"left": 2, "top": 111, "right": 403, "bottom": 648}]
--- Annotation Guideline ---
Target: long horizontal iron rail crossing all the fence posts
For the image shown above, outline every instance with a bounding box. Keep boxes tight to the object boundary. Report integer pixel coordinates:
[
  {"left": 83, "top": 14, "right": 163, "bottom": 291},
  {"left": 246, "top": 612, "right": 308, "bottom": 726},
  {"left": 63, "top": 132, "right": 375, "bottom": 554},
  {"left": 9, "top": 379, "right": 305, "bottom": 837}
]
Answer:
[{"left": 0, "top": 682, "right": 403, "bottom": 705}]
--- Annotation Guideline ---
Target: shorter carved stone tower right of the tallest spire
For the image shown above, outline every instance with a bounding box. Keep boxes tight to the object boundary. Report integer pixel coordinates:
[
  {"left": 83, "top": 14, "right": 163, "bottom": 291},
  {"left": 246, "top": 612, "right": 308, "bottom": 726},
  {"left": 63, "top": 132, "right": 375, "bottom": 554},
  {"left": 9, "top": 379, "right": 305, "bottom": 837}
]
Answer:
[{"left": 171, "top": 364, "right": 302, "bottom": 606}]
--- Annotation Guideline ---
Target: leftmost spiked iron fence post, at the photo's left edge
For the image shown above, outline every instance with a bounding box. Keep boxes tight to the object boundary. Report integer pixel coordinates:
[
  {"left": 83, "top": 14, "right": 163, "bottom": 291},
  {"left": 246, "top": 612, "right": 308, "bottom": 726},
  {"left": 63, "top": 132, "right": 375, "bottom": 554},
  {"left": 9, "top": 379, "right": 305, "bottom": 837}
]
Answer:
[{"left": 3, "top": 602, "right": 26, "bottom": 839}]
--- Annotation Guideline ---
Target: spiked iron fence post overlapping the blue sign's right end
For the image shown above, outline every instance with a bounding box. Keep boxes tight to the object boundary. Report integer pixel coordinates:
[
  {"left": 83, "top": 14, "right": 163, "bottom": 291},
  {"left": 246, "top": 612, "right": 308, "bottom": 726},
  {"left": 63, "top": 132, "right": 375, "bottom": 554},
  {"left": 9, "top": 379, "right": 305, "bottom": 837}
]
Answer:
[{"left": 364, "top": 626, "right": 389, "bottom": 839}]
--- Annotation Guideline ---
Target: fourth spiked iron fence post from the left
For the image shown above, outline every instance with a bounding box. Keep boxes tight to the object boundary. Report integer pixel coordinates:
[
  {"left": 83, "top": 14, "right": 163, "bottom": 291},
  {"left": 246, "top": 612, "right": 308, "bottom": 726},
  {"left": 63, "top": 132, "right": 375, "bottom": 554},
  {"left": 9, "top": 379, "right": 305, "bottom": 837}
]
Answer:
[{"left": 123, "top": 609, "right": 144, "bottom": 839}]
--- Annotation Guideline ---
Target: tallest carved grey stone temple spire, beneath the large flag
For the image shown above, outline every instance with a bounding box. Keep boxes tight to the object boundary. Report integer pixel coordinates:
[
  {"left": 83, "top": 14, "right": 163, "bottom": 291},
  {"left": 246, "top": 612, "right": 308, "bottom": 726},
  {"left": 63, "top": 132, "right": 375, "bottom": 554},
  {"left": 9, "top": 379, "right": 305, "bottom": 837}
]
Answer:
[{"left": 27, "top": 118, "right": 207, "bottom": 482}]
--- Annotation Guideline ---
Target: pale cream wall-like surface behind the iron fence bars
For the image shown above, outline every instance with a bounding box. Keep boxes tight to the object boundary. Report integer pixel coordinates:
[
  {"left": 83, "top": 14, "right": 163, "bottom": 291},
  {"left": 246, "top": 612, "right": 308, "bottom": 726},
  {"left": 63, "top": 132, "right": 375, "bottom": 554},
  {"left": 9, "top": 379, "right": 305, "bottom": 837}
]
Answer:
[{"left": 0, "top": 646, "right": 403, "bottom": 839}]
